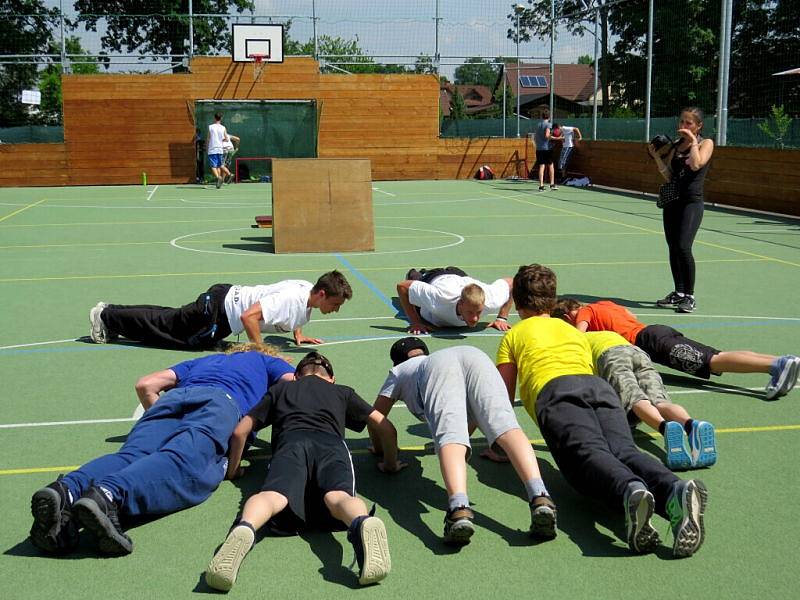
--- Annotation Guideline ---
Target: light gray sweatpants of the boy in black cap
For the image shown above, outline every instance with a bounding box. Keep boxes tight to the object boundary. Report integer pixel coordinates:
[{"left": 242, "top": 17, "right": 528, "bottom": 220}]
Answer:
[{"left": 419, "top": 346, "right": 520, "bottom": 452}]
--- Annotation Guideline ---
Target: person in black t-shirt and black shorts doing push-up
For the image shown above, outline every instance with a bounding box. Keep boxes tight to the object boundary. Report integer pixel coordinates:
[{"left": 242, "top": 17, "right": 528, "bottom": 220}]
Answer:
[{"left": 205, "top": 352, "right": 405, "bottom": 591}]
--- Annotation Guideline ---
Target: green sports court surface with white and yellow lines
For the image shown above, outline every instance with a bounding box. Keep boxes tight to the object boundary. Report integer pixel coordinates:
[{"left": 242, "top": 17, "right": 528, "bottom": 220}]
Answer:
[{"left": 0, "top": 180, "right": 800, "bottom": 599}]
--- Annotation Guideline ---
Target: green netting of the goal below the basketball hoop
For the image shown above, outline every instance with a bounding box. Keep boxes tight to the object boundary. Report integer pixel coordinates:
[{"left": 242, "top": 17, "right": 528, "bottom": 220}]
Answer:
[{"left": 195, "top": 100, "right": 317, "bottom": 166}]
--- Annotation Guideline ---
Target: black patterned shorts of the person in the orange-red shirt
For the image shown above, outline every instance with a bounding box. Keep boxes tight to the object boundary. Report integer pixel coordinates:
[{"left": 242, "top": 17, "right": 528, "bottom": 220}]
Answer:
[{"left": 636, "top": 325, "right": 719, "bottom": 379}]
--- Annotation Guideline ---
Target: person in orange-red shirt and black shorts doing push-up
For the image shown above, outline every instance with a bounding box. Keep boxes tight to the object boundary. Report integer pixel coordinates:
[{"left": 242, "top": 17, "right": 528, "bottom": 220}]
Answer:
[{"left": 552, "top": 298, "right": 800, "bottom": 400}]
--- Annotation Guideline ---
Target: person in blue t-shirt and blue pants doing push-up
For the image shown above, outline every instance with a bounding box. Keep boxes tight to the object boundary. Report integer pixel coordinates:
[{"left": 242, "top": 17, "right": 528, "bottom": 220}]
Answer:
[{"left": 30, "top": 344, "right": 294, "bottom": 555}]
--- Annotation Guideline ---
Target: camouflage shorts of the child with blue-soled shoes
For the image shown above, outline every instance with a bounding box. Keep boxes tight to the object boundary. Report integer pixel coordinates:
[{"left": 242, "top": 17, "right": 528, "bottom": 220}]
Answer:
[{"left": 597, "top": 344, "right": 671, "bottom": 413}]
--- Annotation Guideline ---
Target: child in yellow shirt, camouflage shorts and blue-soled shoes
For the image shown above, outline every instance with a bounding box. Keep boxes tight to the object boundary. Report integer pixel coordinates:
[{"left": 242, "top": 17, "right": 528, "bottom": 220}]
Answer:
[{"left": 580, "top": 328, "right": 717, "bottom": 471}]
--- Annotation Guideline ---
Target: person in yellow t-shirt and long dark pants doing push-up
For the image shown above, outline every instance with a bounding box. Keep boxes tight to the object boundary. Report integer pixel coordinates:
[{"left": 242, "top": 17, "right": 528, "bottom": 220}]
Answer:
[{"left": 496, "top": 264, "right": 708, "bottom": 557}]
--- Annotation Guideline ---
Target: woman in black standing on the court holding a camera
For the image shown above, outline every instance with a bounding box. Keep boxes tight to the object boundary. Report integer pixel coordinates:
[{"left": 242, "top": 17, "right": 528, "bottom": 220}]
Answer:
[{"left": 648, "top": 107, "right": 714, "bottom": 313}]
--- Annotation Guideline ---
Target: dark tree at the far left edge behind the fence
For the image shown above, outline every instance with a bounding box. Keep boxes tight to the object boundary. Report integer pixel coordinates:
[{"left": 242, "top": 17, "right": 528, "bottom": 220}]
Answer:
[{"left": 0, "top": 0, "right": 58, "bottom": 127}]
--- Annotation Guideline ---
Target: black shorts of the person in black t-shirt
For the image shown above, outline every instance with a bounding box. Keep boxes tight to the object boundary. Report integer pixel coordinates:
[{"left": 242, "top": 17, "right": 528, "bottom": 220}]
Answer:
[{"left": 261, "top": 431, "right": 356, "bottom": 535}]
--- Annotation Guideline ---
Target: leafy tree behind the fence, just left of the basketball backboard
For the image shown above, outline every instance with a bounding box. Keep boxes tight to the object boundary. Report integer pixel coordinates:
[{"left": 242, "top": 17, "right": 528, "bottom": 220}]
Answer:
[{"left": 71, "top": 0, "right": 255, "bottom": 72}]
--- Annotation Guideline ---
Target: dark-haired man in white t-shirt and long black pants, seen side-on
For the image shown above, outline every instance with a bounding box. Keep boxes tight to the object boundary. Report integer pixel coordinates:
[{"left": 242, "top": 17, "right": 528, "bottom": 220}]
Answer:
[{"left": 89, "top": 271, "right": 353, "bottom": 349}]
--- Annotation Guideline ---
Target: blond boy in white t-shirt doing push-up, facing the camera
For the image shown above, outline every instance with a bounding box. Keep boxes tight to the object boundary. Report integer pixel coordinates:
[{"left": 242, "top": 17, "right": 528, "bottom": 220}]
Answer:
[{"left": 397, "top": 267, "right": 513, "bottom": 334}]
